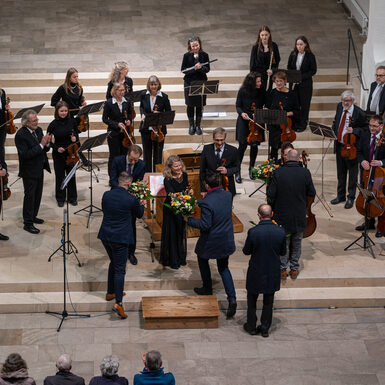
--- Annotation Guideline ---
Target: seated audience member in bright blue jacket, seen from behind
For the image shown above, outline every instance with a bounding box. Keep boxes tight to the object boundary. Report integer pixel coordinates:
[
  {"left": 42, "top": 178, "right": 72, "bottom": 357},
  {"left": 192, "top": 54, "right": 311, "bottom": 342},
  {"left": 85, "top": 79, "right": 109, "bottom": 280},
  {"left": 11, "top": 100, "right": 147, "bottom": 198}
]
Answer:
[{"left": 134, "top": 350, "right": 175, "bottom": 385}]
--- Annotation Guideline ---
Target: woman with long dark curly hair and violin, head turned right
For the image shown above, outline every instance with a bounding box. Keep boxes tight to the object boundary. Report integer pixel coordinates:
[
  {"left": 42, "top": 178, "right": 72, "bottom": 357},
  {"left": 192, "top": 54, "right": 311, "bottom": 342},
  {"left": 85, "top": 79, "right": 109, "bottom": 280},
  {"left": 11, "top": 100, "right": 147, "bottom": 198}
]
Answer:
[{"left": 235, "top": 72, "right": 266, "bottom": 183}]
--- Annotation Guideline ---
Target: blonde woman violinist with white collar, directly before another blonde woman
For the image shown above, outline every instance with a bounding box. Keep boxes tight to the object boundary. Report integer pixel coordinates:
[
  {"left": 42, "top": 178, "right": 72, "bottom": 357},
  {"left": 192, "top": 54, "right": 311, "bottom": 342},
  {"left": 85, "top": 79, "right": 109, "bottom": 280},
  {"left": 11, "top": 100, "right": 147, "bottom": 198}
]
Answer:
[{"left": 103, "top": 83, "right": 131, "bottom": 176}]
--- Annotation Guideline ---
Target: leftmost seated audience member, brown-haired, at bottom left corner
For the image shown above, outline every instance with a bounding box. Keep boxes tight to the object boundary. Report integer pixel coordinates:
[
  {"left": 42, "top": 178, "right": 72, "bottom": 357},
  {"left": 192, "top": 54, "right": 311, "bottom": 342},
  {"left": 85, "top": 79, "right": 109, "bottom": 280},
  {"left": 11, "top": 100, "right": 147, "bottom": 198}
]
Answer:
[{"left": 0, "top": 353, "right": 36, "bottom": 385}]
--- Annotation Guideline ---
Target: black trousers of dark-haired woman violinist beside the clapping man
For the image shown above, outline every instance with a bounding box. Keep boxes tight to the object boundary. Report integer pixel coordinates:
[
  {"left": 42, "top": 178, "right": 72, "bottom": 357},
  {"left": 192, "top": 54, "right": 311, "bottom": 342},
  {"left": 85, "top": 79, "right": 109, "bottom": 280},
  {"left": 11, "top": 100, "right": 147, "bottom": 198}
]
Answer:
[{"left": 52, "top": 152, "right": 78, "bottom": 202}]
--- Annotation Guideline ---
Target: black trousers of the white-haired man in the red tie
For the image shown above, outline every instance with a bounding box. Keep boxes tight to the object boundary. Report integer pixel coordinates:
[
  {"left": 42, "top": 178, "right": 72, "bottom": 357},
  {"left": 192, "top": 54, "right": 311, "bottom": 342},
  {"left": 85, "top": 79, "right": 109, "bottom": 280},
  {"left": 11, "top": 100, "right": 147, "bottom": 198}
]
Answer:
[{"left": 336, "top": 143, "right": 358, "bottom": 199}]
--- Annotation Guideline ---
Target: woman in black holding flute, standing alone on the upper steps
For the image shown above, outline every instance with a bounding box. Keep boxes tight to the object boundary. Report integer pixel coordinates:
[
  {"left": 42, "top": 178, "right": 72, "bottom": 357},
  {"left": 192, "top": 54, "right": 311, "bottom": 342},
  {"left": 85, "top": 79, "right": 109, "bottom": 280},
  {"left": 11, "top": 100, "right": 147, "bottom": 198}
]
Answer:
[{"left": 181, "top": 36, "right": 210, "bottom": 135}]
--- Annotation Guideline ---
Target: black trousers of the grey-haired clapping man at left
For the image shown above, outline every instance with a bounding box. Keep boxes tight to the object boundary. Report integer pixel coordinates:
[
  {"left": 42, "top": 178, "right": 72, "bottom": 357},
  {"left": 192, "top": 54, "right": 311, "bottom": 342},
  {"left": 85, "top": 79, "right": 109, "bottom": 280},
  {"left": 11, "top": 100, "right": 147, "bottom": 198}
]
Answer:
[{"left": 23, "top": 172, "right": 44, "bottom": 226}]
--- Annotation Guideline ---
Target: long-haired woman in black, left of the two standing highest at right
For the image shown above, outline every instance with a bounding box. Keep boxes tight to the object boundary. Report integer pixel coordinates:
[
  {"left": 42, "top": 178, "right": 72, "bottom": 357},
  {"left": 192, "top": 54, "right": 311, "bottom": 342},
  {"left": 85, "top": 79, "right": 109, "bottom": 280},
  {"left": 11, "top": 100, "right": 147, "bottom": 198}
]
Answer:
[{"left": 250, "top": 26, "right": 281, "bottom": 90}]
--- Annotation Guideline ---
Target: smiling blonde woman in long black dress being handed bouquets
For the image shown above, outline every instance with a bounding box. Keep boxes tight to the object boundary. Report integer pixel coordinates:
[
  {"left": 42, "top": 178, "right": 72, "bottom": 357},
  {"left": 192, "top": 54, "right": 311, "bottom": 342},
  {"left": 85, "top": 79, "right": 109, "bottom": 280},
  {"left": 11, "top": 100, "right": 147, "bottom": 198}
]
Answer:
[{"left": 160, "top": 155, "right": 193, "bottom": 269}]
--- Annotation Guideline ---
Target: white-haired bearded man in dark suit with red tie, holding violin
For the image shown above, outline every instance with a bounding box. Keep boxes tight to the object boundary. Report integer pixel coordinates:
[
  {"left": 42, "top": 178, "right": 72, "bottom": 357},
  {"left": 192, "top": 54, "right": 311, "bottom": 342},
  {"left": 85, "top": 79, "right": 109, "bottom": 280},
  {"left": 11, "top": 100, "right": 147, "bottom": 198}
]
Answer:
[{"left": 330, "top": 91, "right": 367, "bottom": 209}]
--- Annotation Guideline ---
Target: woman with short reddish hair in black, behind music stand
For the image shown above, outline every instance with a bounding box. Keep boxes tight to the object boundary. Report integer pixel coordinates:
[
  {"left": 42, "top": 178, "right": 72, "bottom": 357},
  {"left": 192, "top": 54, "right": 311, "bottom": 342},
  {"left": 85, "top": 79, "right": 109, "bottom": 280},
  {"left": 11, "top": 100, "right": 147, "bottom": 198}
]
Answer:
[{"left": 266, "top": 71, "right": 299, "bottom": 162}]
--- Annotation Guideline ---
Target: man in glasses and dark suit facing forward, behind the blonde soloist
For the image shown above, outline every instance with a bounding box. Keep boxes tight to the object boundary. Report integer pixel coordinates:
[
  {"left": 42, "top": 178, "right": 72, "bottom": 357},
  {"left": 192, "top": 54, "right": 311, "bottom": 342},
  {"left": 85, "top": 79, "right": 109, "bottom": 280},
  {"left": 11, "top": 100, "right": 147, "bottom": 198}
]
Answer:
[{"left": 199, "top": 127, "right": 239, "bottom": 197}]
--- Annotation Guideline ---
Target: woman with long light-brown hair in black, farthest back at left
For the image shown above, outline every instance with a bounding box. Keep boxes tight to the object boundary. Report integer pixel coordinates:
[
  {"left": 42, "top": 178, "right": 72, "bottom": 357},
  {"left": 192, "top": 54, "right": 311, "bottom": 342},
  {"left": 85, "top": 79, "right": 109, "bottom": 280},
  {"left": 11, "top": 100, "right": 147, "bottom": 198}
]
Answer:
[{"left": 51, "top": 67, "right": 87, "bottom": 117}]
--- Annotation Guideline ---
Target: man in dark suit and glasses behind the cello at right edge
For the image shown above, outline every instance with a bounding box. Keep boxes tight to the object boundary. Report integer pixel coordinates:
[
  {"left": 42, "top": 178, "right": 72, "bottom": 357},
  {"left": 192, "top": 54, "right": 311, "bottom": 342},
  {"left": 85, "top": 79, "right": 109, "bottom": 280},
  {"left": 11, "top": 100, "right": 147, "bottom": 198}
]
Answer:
[{"left": 356, "top": 115, "right": 385, "bottom": 238}]
